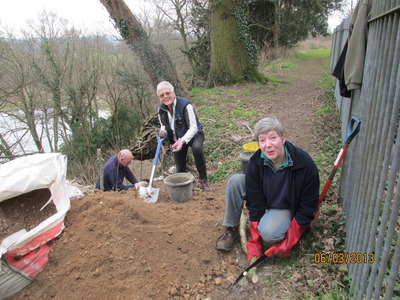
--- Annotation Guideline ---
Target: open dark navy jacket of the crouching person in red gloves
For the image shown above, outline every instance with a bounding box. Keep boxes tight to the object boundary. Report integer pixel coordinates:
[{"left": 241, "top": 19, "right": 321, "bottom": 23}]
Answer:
[{"left": 246, "top": 141, "right": 319, "bottom": 226}]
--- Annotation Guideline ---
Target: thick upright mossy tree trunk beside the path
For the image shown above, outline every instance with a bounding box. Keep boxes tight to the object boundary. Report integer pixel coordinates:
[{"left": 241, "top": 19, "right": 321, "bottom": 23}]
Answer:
[{"left": 208, "top": 0, "right": 258, "bottom": 86}]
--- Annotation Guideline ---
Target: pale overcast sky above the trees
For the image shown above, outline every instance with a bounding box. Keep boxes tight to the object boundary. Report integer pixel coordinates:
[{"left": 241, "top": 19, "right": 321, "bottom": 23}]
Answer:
[{"left": 0, "top": 0, "right": 340, "bottom": 34}]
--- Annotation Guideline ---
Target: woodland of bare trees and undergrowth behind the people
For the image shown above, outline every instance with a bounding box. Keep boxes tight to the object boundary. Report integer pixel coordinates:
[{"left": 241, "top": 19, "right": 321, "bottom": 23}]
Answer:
[{"left": 0, "top": 0, "right": 354, "bottom": 184}]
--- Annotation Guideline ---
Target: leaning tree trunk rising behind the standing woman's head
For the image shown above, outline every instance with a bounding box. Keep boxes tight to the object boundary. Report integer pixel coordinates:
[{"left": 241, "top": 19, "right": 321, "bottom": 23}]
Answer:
[{"left": 100, "top": 0, "right": 188, "bottom": 97}]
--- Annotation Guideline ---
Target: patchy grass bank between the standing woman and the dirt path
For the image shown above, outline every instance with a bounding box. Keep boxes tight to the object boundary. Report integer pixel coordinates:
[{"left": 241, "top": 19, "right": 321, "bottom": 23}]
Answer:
[{"left": 191, "top": 85, "right": 267, "bottom": 178}]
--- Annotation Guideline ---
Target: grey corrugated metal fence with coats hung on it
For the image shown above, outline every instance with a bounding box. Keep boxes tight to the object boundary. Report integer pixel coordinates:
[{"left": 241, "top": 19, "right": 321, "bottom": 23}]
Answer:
[{"left": 331, "top": 0, "right": 400, "bottom": 299}]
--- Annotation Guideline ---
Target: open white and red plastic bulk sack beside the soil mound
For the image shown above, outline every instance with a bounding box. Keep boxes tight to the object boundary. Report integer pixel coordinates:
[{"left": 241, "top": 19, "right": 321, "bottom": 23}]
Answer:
[{"left": 0, "top": 153, "right": 72, "bottom": 299}]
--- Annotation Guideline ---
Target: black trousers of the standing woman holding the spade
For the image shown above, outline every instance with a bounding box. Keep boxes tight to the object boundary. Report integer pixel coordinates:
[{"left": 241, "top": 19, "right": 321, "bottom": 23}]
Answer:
[{"left": 174, "top": 132, "right": 207, "bottom": 179}]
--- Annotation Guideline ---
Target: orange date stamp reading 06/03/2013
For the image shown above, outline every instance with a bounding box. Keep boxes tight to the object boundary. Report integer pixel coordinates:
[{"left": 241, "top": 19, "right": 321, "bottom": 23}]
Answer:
[{"left": 313, "top": 252, "right": 375, "bottom": 264}]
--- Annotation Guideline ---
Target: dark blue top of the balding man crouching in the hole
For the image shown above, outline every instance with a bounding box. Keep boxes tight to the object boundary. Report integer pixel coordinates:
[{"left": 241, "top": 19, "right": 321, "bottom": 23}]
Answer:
[{"left": 96, "top": 155, "right": 138, "bottom": 191}]
